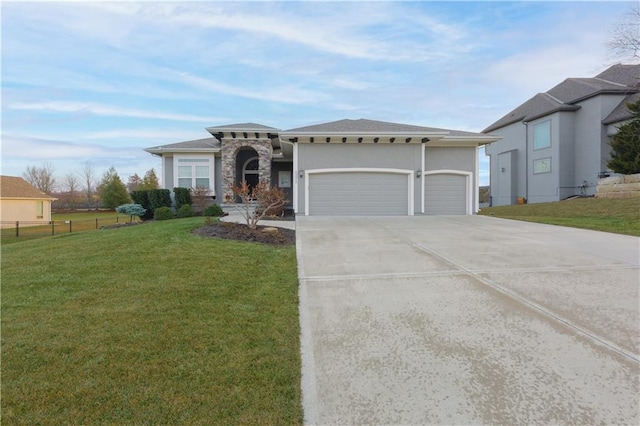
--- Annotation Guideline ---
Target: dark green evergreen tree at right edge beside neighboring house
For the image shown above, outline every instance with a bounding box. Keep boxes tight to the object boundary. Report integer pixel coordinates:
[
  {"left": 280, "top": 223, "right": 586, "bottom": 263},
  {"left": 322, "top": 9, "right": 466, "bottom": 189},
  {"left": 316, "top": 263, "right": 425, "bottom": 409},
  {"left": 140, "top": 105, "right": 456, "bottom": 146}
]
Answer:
[{"left": 607, "top": 100, "right": 640, "bottom": 175}]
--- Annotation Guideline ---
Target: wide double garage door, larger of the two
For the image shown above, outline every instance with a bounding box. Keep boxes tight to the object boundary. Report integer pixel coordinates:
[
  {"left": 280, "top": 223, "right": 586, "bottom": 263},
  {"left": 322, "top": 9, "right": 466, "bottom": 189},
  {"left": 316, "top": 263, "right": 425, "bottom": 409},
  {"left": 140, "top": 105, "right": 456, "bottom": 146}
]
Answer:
[{"left": 307, "top": 172, "right": 409, "bottom": 216}]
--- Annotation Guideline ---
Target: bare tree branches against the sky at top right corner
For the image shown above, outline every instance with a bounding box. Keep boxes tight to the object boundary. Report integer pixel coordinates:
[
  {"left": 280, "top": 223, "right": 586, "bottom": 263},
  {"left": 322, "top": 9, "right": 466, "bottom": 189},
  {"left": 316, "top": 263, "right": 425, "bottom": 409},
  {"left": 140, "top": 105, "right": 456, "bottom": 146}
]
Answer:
[{"left": 607, "top": 0, "right": 640, "bottom": 61}]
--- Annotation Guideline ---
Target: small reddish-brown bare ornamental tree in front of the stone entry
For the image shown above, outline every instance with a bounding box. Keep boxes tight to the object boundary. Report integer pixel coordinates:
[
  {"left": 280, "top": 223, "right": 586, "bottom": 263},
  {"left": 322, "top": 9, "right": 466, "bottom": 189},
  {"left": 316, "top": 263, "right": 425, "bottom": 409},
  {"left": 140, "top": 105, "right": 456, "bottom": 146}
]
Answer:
[{"left": 229, "top": 181, "right": 287, "bottom": 229}]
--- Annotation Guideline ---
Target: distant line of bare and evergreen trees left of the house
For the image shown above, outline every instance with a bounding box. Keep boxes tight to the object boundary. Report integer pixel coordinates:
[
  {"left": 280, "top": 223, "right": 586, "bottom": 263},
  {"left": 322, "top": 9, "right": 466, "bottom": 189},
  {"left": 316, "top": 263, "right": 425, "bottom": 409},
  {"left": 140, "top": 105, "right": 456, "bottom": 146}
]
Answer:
[{"left": 22, "top": 161, "right": 160, "bottom": 210}]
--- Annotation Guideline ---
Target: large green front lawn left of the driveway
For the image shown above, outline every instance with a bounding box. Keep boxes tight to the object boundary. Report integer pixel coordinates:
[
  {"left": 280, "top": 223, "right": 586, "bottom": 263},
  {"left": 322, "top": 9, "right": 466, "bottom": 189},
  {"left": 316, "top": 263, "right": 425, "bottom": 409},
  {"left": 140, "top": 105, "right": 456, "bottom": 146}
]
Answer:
[{"left": 1, "top": 218, "right": 302, "bottom": 425}]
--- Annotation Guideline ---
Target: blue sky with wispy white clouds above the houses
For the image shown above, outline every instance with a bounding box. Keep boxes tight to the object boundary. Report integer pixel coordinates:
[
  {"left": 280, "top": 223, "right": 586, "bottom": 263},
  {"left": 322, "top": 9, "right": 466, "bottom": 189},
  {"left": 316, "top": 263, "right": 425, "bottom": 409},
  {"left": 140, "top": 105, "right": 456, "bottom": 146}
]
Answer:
[{"left": 0, "top": 1, "right": 628, "bottom": 184}]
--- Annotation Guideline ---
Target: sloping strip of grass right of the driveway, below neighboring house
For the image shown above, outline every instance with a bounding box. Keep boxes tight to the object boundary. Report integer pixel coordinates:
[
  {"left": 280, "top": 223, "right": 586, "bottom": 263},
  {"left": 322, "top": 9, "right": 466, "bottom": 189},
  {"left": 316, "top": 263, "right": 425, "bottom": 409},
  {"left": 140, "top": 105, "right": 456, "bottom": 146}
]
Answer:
[{"left": 479, "top": 197, "right": 640, "bottom": 236}]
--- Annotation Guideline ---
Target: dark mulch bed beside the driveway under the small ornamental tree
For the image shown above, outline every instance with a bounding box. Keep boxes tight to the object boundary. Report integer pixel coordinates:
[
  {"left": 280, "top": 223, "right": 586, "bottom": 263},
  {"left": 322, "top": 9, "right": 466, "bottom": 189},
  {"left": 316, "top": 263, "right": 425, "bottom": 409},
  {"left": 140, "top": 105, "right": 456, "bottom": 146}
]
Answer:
[{"left": 193, "top": 222, "right": 296, "bottom": 246}]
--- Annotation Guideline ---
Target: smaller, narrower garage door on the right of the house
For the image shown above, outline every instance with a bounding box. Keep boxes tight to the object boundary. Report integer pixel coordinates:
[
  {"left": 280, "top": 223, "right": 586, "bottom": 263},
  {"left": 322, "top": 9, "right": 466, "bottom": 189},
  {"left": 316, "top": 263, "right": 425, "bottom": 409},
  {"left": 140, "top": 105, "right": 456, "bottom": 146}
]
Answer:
[{"left": 424, "top": 173, "right": 467, "bottom": 215}]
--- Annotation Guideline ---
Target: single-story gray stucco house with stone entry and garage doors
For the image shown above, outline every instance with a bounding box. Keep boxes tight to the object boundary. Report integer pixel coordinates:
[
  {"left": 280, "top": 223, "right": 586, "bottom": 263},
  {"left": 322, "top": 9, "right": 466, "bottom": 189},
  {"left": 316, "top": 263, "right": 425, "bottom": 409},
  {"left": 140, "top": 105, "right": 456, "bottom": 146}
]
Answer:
[{"left": 145, "top": 119, "right": 498, "bottom": 215}]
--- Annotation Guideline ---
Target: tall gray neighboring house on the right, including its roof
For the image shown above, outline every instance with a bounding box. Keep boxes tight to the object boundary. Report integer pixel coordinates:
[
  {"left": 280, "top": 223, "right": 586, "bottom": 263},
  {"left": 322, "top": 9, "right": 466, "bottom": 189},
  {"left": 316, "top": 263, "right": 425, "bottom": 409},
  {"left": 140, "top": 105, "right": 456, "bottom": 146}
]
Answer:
[{"left": 483, "top": 65, "right": 640, "bottom": 205}]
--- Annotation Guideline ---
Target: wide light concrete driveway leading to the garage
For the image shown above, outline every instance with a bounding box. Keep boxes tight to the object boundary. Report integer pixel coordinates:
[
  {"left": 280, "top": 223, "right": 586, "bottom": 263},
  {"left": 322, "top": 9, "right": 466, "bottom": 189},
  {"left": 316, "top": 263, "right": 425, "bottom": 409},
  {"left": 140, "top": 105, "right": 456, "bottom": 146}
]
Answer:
[{"left": 296, "top": 216, "right": 640, "bottom": 425}]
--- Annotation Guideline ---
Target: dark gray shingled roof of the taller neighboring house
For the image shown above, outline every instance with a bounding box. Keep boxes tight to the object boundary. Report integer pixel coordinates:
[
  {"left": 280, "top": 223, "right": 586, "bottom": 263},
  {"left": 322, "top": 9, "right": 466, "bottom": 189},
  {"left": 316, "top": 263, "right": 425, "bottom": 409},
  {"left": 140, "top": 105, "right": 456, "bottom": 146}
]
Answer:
[{"left": 483, "top": 65, "right": 640, "bottom": 133}]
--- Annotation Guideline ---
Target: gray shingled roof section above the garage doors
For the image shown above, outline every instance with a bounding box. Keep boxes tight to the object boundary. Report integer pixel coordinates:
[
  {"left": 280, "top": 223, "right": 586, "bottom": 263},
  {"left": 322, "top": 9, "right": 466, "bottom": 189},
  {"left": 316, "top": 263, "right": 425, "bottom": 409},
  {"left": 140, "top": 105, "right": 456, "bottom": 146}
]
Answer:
[{"left": 284, "top": 118, "right": 484, "bottom": 136}]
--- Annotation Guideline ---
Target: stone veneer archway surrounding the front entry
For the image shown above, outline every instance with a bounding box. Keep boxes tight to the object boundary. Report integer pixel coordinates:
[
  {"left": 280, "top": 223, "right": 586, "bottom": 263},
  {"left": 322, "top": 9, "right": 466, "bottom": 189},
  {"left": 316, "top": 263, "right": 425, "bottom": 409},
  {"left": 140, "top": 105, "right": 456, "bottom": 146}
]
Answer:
[{"left": 221, "top": 138, "right": 273, "bottom": 203}]
